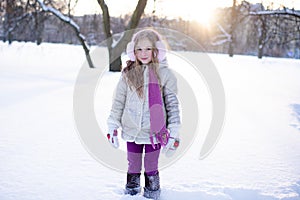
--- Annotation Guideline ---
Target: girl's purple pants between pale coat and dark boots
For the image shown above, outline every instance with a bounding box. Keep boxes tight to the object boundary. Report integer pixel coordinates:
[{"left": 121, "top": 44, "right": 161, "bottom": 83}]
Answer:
[{"left": 127, "top": 142, "right": 161, "bottom": 176}]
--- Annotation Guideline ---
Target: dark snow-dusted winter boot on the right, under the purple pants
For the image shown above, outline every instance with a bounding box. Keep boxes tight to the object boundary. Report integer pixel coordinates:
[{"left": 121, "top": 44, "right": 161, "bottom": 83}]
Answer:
[{"left": 144, "top": 173, "right": 160, "bottom": 200}]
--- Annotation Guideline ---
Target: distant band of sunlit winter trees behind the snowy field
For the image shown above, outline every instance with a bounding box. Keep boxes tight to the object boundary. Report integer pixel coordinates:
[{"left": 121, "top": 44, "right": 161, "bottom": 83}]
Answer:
[{"left": 0, "top": 0, "right": 300, "bottom": 59}]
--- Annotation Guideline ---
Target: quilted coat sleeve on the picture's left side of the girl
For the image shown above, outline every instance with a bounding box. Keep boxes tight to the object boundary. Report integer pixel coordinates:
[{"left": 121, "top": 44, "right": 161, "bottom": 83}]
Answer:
[{"left": 107, "top": 74, "right": 127, "bottom": 133}]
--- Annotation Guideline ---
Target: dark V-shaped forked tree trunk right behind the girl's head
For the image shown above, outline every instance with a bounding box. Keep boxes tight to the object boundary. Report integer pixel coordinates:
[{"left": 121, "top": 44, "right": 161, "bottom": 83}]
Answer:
[{"left": 97, "top": 0, "right": 147, "bottom": 71}]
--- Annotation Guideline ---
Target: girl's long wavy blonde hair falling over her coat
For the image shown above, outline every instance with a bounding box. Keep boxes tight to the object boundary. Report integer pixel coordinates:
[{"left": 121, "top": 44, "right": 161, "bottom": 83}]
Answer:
[{"left": 123, "top": 29, "right": 160, "bottom": 99}]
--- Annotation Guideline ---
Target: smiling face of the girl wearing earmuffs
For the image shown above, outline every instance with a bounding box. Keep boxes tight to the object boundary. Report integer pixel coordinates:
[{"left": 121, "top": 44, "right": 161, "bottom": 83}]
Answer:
[{"left": 135, "top": 39, "right": 152, "bottom": 64}]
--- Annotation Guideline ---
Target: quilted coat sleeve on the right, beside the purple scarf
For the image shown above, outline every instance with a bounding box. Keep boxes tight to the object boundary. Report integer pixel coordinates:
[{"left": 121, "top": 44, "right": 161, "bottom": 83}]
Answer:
[{"left": 163, "top": 68, "right": 181, "bottom": 137}]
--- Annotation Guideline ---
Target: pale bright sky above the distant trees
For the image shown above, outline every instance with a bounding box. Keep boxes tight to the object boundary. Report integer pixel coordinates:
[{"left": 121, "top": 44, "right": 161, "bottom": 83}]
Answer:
[{"left": 75, "top": 0, "right": 300, "bottom": 24}]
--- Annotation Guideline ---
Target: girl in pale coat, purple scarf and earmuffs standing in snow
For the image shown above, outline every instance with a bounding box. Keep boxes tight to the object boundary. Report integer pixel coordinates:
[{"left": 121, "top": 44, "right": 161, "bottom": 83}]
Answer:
[{"left": 107, "top": 29, "right": 180, "bottom": 199}]
